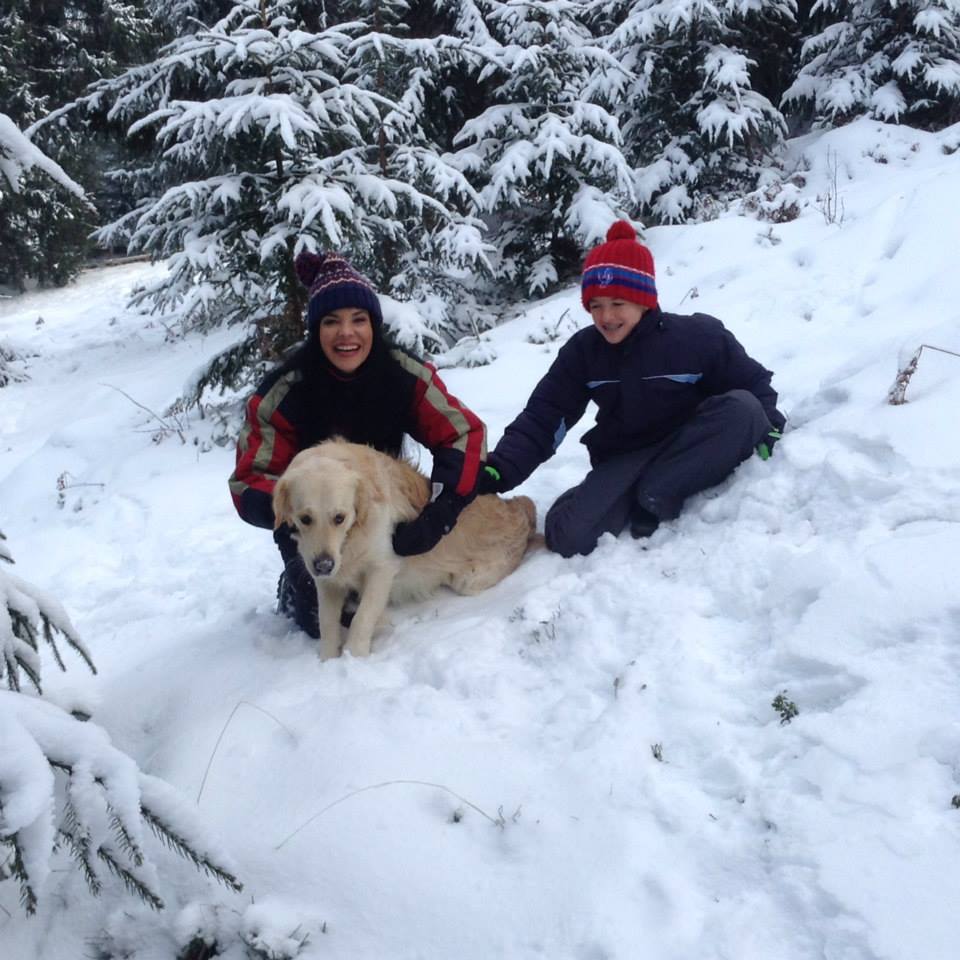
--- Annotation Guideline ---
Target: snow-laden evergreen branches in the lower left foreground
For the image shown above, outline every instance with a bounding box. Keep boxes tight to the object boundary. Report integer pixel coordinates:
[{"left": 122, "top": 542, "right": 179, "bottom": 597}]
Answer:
[{"left": 0, "top": 533, "right": 241, "bottom": 914}]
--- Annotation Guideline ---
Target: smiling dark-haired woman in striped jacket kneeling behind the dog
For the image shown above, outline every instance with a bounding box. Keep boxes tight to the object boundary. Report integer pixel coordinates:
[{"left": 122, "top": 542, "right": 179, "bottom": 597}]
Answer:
[{"left": 230, "top": 253, "right": 486, "bottom": 637}]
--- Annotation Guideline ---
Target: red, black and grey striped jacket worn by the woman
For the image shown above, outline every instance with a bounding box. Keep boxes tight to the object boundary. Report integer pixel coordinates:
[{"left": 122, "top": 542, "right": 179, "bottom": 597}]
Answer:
[{"left": 230, "top": 343, "right": 486, "bottom": 528}]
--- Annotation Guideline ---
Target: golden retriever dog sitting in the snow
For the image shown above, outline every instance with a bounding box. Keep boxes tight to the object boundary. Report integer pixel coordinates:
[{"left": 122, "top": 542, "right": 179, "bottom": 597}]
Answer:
[{"left": 273, "top": 438, "right": 536, "bottom": 660}]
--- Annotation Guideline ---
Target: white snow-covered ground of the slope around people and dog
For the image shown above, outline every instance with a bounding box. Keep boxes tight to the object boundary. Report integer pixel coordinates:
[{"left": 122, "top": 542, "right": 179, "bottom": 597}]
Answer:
[{"left": 0, "top": 121, "right": 960, "bottom": 960}]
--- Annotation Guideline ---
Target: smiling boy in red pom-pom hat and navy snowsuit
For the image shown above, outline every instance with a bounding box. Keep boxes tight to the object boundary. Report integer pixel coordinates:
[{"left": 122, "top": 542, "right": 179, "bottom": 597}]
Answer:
[{"left": 478, "top": 220, "right": 785, "bottom": 557}]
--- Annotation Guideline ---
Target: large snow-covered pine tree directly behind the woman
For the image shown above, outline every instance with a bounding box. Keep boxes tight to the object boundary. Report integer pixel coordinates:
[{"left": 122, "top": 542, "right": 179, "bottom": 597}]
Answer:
[{"left": 79, "top": 0, "right": 481, "bottom": 390}]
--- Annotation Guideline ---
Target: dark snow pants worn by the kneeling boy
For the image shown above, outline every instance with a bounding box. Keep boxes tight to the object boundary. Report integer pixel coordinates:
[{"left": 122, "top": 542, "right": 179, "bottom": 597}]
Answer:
[{"left": 544, "top": 390, "right": 771, "bottom": 557}]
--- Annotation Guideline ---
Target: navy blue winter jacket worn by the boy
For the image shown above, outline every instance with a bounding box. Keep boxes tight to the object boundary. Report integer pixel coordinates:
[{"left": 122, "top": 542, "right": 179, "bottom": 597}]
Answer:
[{"left": 488, "top": 308, "right": 785, "bottom": 490}]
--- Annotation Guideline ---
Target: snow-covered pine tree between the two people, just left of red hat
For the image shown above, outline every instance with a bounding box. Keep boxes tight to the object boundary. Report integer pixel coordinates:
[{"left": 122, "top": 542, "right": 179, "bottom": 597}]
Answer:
[{"left": 444, "top": 0, "right": 635, "bottom": 296}]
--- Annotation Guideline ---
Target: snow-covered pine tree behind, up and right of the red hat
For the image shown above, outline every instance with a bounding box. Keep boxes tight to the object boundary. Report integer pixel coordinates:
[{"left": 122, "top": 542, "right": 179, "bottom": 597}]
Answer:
[{"left": 591, "top": 0, "right": 795, "bottom": 222}]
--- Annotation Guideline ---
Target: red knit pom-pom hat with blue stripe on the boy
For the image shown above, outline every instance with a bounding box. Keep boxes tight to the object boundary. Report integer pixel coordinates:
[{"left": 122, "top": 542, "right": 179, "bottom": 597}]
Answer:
[{"left": 580, "top": 220, "right": 657, "bottom": 310}]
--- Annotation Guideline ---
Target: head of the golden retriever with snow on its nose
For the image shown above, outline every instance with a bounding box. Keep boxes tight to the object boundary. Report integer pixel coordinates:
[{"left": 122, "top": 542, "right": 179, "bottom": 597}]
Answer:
[{"left": 273, "top": 450, "right": 367, "bottom": 579}]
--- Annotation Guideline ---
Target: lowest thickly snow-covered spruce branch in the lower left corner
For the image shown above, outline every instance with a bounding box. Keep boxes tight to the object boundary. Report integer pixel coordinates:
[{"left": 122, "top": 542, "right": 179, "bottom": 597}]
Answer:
[{"left": 0, "top": 691, "right": 242, "bottom": 914}]
